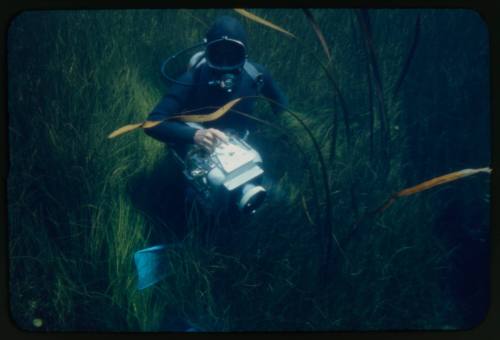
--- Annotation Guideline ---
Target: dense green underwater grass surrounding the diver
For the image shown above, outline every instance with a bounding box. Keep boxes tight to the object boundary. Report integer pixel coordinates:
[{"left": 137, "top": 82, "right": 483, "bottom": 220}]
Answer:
[{"left": 8, "top": 9, "right": 490, "bottom": 331}]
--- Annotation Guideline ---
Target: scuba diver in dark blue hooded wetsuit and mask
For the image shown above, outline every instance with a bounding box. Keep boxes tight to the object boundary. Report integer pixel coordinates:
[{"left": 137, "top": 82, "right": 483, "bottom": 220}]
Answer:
[{"left": 144, "top": 16, "right": 287, "bottom": 223}]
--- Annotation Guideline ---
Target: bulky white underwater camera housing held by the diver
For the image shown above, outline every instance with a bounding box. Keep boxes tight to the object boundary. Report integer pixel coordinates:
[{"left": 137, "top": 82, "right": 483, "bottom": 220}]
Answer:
[{"left": 183, "top": 131, "right": 266, "bottom": 214}]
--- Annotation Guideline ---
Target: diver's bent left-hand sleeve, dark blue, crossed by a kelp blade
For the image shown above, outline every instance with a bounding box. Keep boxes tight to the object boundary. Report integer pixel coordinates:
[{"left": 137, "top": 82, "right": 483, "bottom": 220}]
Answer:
[{"left": 144, "top": 72, "right": 196, "bottom": 144}]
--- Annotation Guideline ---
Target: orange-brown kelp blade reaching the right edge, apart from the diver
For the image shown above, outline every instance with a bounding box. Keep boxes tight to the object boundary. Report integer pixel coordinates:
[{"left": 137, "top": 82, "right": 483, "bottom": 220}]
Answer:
[{"left": 343, "top": 167, "right": 492, "bottom": 244}]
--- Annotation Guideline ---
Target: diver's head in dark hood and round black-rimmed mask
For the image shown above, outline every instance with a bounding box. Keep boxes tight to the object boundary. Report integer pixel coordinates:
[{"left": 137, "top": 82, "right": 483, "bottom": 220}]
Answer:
[{"left": 205, "top": 16, "right": 247, "bottom": 72}]
